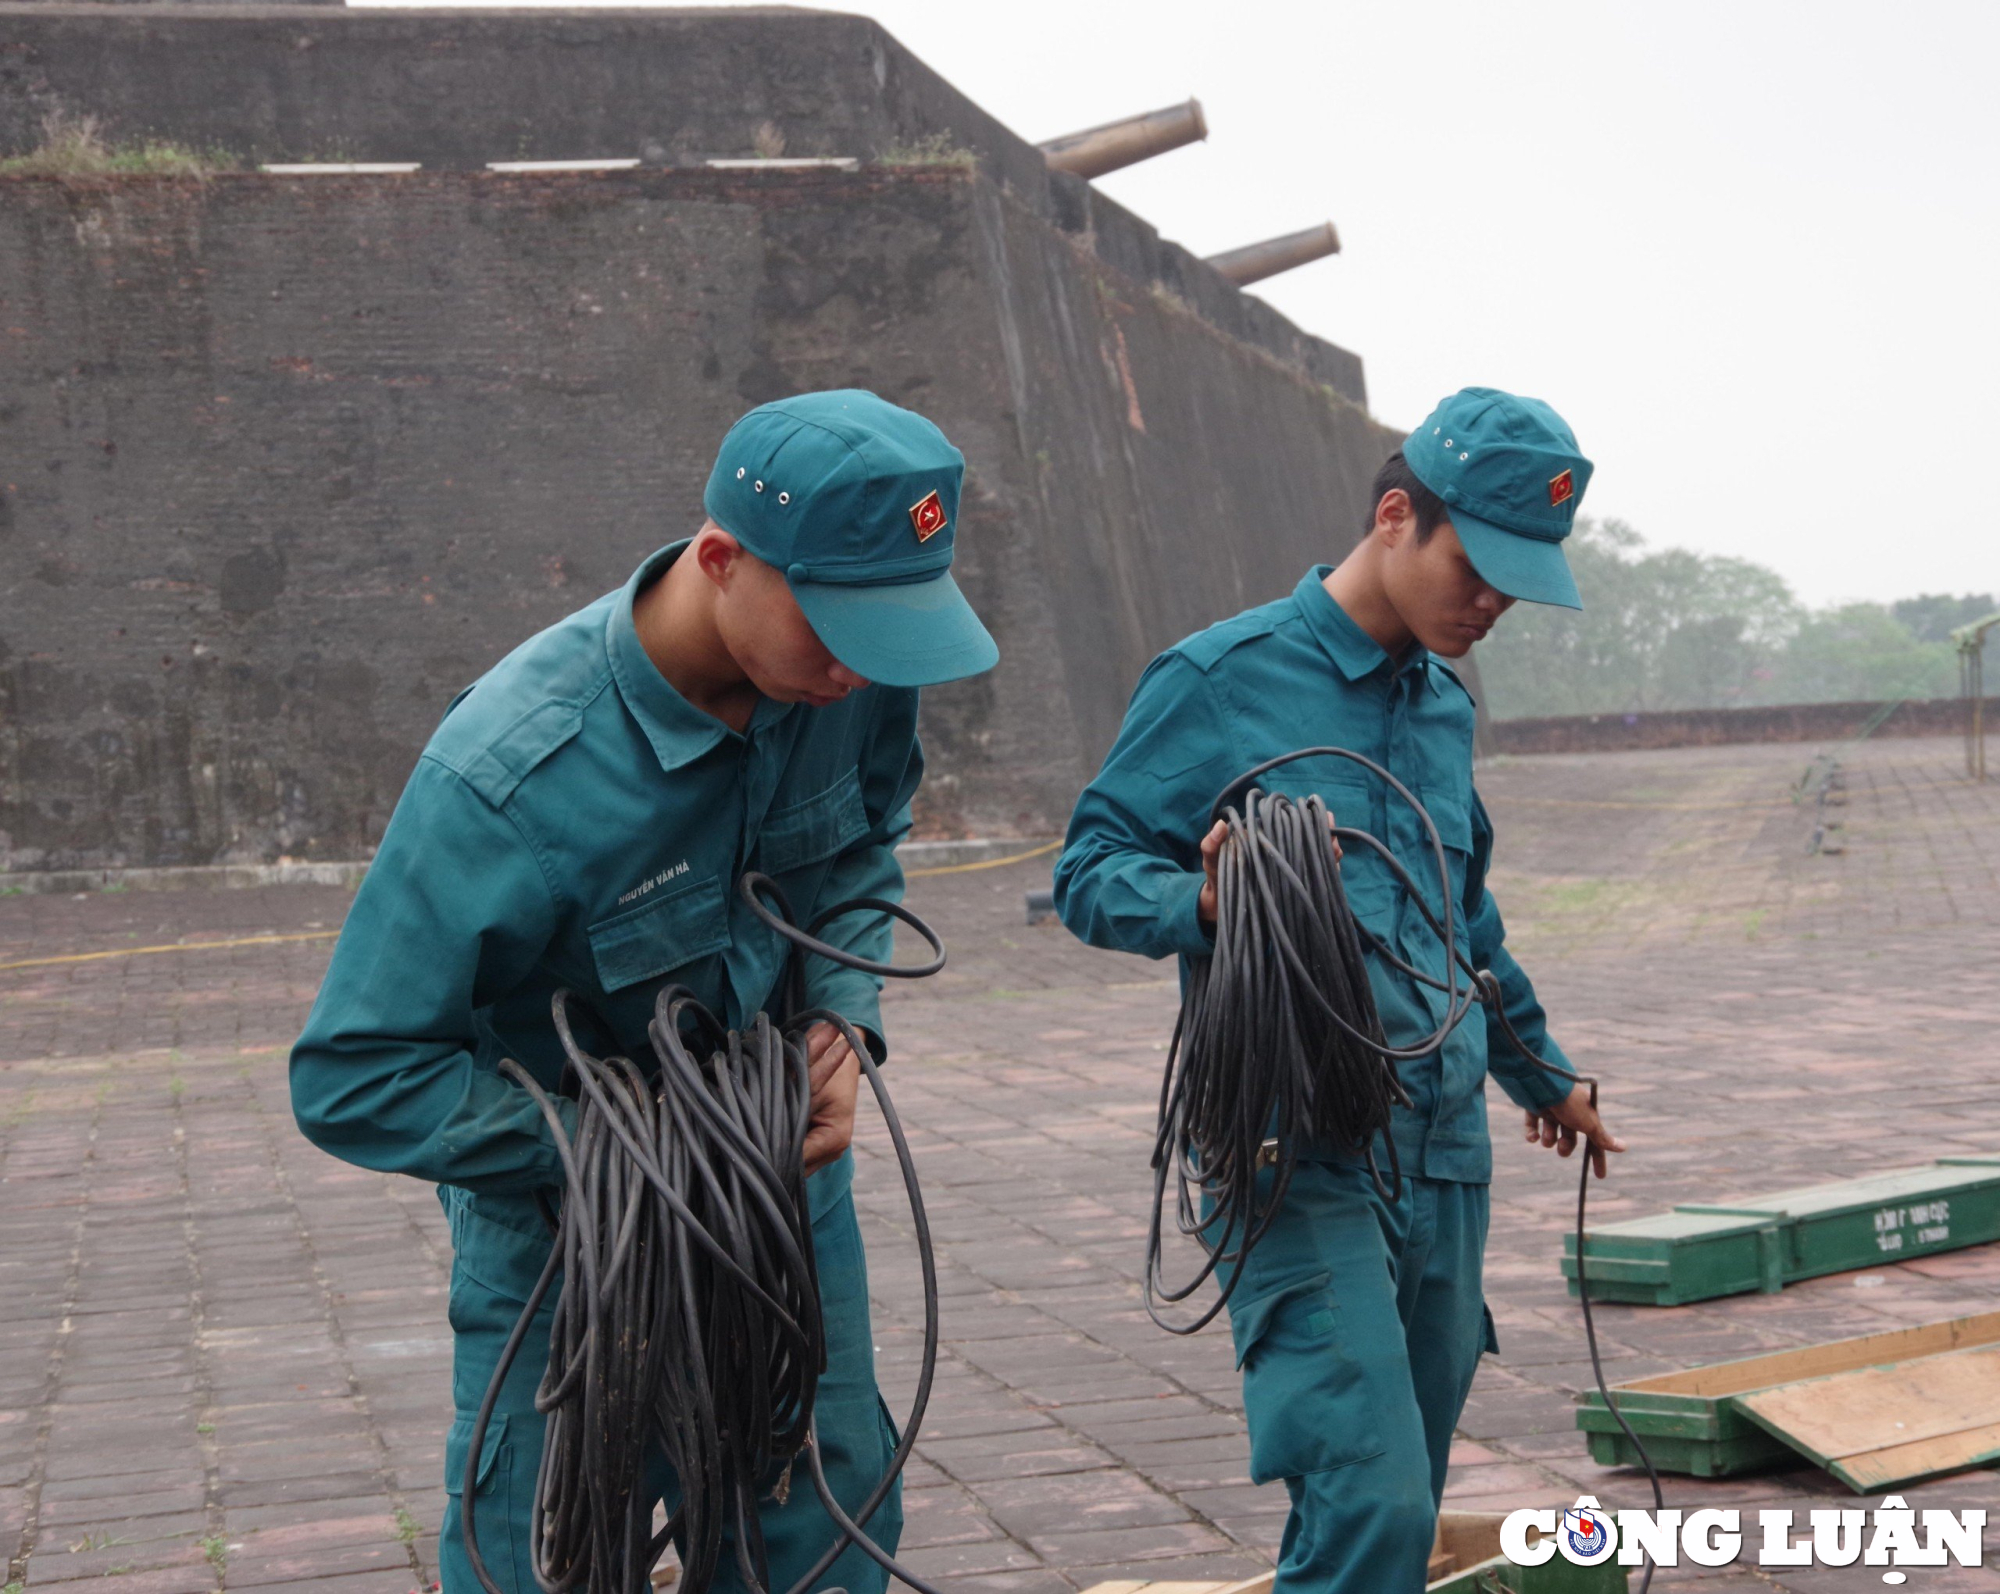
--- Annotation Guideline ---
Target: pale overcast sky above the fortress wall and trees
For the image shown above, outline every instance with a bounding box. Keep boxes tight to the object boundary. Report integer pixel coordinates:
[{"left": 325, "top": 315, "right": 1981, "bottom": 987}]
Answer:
[{"left": 364, "top": 0, "right": 2000, "bottom": 602}]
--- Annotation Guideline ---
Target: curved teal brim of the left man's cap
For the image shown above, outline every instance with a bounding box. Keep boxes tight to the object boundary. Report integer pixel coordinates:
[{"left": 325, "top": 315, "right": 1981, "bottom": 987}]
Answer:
[{"left": 792, "top": 570, "right": 1000, "bottom": 686}]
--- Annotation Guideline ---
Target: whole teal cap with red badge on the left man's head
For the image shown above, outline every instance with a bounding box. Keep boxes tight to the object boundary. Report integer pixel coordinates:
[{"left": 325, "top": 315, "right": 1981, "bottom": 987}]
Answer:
[{"left": 702, "top": 388, "right": 1000, "bottom": 686}]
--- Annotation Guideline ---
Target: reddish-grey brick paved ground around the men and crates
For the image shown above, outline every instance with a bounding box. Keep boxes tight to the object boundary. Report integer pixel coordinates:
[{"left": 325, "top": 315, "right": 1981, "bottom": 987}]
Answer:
[{"left": 0, "top": 742, "right": 2000, "bottom": 1594}]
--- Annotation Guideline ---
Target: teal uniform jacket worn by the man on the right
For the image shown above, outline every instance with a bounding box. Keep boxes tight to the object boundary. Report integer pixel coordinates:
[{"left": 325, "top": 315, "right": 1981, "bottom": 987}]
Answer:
[{"left": 1056, "top": 566, "right": 1568, "bottom": 1184}]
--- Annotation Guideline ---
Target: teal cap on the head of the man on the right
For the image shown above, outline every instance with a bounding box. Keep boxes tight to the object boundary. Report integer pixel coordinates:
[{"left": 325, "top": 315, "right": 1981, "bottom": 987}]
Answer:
[{"left": 1402, "top": 388, "right": 1592, "bottom": 608}]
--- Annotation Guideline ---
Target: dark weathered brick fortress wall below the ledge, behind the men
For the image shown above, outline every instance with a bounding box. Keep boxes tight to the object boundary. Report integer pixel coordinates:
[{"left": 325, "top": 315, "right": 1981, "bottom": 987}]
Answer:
[{"left": 0, "top": 166, "right": 1394, "bottom": 868}]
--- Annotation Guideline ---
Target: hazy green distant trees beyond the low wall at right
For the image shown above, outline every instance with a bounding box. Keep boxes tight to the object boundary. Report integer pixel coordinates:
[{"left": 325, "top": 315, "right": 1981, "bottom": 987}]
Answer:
[{"left": 1474, "top": 520, "right": 2000, "bottom": 720}]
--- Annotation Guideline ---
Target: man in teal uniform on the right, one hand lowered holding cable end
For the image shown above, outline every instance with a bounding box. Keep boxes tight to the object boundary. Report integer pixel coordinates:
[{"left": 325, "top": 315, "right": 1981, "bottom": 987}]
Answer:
[{"left": 1056, "top": 388, "right": 1622, "bottom": 1594}]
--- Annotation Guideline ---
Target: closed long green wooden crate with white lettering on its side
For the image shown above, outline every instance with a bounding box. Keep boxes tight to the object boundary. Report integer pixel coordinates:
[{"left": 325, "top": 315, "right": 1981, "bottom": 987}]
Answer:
[{"left": 1562, "top": 1156, "right": 2000, "bottom": 1306}]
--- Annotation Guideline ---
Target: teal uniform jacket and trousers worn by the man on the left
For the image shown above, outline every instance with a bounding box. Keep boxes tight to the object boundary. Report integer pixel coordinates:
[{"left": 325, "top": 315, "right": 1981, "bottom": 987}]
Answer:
[{"left": 292, "top": 542, "right": 924, "bottom": 1594}]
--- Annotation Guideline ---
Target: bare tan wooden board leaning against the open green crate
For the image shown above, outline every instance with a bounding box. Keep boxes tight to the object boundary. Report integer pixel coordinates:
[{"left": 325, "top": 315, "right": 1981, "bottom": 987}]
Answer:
[{"left": 1736, "top": 1346, "right": 2000, "bottom": 1492}]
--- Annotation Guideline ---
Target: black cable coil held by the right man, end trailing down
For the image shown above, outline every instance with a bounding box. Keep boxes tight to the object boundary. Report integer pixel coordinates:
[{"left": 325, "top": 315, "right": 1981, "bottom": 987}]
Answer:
[{"left": 1146, "top": 746, "right": 1666, "bottom": 1594}]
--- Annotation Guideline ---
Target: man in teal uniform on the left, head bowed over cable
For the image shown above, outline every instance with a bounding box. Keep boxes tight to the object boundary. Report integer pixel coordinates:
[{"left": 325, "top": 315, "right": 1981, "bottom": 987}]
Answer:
[{"left": 292, "top": 392, "right": 998, "bottom": 1594}]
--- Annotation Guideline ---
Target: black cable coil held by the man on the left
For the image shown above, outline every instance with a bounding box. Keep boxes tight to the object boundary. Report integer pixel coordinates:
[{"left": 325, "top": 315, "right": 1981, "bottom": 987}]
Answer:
[{"left": 462, "top": 874, "right": 960, "bottom": 1594}]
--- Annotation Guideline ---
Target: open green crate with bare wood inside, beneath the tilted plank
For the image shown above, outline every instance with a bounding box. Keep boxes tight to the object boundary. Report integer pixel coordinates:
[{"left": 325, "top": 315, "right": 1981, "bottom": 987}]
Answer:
[{"left": 1576, "top": 1312, "right": 2000, "bottom": 1478}]
